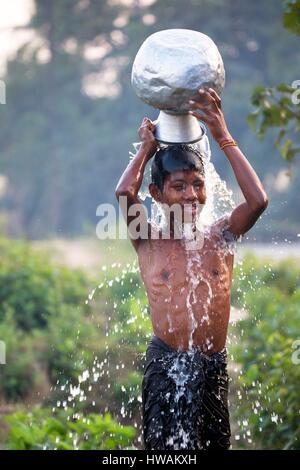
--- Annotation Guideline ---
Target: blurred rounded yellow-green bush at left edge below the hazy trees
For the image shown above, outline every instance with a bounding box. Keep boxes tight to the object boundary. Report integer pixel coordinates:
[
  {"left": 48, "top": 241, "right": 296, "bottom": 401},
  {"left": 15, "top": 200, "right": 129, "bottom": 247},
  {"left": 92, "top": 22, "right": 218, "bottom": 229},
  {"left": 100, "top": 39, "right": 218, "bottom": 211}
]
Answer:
[{"left": 0, "top": 239, "right": 88, "bottom": 332}]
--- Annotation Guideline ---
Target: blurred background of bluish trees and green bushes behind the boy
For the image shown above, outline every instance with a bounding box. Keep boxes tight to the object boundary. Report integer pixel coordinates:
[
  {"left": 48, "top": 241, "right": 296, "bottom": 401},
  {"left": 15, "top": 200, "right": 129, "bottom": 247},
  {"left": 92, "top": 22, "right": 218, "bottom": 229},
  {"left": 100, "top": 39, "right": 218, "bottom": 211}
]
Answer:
[{"left": 0, "top": 0, "right": 300, "bottom": 449}]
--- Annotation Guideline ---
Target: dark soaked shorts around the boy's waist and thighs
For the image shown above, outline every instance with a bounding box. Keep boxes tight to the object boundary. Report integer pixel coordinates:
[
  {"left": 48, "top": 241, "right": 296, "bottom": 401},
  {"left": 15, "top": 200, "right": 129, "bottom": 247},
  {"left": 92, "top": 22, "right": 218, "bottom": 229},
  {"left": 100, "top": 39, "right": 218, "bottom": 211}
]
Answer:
[{"left": 142, "top": 336, "right": 230, "bottom": 450}]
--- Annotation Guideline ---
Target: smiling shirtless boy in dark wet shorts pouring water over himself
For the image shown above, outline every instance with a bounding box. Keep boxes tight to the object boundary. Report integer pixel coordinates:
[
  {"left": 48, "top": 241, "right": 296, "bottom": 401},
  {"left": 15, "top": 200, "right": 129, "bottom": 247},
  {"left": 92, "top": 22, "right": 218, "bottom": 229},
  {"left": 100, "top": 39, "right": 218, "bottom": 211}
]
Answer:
[{"left": 116, "top": 88, "right": 268, "bottom": 450}]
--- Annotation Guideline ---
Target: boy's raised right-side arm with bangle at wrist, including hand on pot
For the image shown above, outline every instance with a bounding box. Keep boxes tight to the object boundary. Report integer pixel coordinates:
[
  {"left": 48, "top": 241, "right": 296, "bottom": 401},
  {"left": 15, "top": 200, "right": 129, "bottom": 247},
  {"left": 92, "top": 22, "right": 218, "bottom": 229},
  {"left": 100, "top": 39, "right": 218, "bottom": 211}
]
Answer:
[{"left": 190, "top": 88, "right": 268, "bottom": 235}]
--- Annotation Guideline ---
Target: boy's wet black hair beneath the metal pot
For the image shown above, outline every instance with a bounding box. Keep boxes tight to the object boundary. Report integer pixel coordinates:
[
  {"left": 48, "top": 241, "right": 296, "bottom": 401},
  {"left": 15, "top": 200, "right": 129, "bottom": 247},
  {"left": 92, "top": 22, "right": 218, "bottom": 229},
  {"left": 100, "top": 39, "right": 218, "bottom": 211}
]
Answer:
[{"left": 151, "top": 144, "right": 204, "bottom": 191}]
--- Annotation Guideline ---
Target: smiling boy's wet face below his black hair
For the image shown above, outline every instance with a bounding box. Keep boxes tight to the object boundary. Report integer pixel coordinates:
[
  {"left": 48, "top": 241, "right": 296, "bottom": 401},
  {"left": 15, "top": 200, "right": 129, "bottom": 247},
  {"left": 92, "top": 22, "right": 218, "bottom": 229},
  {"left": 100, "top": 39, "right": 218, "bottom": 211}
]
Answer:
[{"left": 149, "top": 170, "right": 206, "bottom": 222}]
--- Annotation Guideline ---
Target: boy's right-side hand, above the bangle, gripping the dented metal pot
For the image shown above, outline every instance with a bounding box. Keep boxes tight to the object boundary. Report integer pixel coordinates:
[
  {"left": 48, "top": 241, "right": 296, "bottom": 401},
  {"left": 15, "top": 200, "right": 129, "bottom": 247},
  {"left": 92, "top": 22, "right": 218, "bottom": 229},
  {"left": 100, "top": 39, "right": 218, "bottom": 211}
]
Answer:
[{"left": 189, "top": 88, "right": 232, "bottom": 143}]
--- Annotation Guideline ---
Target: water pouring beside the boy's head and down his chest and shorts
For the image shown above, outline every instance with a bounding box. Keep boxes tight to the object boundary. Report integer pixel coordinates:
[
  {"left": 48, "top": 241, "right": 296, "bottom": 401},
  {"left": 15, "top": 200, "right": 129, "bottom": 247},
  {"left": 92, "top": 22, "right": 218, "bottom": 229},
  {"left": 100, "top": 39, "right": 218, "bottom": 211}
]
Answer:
[{"left": 120, "top": 135, "right": 235, "bottom": 448}]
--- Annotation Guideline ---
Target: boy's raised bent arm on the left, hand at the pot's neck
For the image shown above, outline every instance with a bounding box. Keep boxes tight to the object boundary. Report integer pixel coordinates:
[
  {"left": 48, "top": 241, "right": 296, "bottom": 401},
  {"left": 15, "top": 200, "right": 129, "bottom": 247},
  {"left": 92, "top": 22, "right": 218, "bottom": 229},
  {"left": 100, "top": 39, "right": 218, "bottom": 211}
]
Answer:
[{"left": 115, "top": 118, "right": 157, "bottom": 249}]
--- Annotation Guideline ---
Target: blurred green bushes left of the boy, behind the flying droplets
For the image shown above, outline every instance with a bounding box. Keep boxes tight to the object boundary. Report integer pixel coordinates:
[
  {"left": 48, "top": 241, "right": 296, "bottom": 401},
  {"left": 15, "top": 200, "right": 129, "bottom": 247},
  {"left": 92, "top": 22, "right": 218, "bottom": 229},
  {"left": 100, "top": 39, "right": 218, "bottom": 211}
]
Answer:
[{"left": 0, "top": 240, "right": 151, "bottom": 414}]
